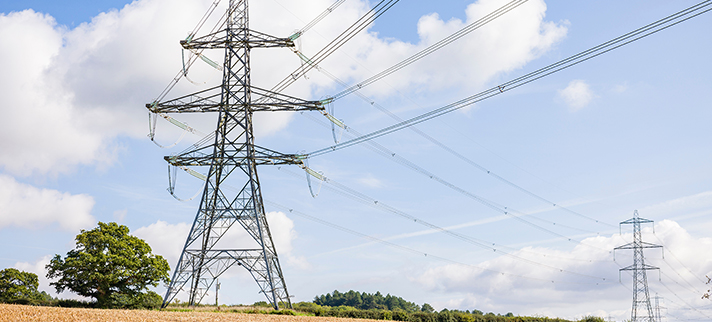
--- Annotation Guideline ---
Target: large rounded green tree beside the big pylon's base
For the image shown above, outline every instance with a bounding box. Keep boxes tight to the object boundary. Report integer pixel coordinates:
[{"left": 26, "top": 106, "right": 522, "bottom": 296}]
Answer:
[{"left": 46, "top": 222, "right": 170, "bottom": 308}]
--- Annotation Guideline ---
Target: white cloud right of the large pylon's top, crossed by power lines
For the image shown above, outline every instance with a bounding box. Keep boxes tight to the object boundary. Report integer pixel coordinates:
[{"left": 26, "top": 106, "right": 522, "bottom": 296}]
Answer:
[{"left": 314, "top": 0, "right": 567, "bottom": 96}]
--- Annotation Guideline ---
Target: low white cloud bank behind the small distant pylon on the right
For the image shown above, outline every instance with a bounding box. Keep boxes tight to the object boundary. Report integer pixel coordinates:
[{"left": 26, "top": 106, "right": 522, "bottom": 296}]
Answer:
[{"left": 414, "top": 220, "right": 712, "bottom": 319}]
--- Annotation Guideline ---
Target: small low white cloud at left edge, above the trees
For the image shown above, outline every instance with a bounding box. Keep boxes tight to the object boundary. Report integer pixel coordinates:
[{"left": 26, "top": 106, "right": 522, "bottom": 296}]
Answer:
[{"left": 0, "top": 174, "right": 96, "bottom": 231}]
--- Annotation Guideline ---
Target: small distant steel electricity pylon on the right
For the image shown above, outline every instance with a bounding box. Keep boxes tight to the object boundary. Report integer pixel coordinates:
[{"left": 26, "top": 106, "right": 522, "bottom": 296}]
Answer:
[{"left": 614, "top": 210, "right": 662, "bottom": 322}]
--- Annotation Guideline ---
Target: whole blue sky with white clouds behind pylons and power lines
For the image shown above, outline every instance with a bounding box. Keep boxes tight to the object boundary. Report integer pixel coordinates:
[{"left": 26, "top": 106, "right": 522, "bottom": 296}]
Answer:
[{"left": 0, "top": 0, "right": 712, "bottom": 321}]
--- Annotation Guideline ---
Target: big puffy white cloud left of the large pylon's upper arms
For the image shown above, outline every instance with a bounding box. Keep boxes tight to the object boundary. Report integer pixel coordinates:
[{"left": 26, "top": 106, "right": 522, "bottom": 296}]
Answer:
[{"left": 0, "top": 1, "right": 217, "bottom": 175}]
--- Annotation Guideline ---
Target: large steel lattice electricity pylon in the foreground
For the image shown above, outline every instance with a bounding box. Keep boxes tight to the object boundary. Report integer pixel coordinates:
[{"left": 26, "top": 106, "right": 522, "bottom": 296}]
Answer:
[{"left": 146, "top": 0, "right": 324, "bottom": 309}]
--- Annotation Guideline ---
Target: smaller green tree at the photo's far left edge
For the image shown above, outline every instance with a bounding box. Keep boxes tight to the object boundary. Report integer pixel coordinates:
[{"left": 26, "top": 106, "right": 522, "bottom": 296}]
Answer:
[{"left": 0, "top": 268, "right": 42, "bottom": 303}]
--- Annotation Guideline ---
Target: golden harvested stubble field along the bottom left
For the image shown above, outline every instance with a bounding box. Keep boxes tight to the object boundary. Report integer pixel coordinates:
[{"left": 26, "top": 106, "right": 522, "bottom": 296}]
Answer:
[{"left": 0, "top": 304, "right": 372, "bottom": 322}]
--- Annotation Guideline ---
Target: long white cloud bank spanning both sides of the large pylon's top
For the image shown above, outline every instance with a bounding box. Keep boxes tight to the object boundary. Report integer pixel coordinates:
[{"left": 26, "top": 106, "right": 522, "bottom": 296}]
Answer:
[{"left": 0, "top": 0, "right": 566, "bottom": 176}]
